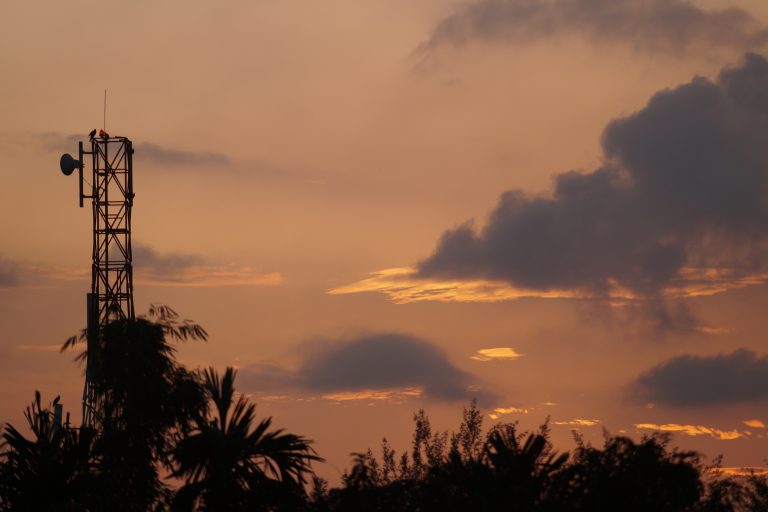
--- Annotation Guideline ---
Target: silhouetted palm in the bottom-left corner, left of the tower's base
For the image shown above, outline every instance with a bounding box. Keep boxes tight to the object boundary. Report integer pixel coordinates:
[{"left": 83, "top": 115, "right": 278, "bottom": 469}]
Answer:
[{"left": 0, "top": 392, "right": 96, "bottom": 510}]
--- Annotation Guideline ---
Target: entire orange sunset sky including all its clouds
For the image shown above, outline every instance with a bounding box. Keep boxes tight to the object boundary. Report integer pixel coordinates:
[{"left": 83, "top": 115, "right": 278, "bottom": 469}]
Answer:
[{"left": 0, "top": 0, "right": 768, "bottom": 482}]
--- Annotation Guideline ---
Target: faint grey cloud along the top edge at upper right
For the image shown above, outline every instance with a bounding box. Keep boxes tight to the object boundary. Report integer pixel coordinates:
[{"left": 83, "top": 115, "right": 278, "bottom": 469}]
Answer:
[{"left": 421, "top": 0, "right": 768, "bottom": 54}]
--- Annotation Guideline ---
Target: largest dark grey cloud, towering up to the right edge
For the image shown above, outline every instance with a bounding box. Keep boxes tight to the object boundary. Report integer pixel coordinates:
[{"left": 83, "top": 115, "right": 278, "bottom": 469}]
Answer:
[{"left": 419, "top": 54, "right": 768, "bottom": 304}]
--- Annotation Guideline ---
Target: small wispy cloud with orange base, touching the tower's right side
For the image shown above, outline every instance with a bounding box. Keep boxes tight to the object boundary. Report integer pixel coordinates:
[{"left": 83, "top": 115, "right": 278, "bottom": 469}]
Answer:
[{"left": 133, "top": 243, "right": 282, "bottom": 287}]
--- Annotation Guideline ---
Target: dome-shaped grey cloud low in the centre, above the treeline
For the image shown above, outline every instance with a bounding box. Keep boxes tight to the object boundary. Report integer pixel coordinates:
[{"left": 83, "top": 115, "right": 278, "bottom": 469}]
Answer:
[{"left": 238, "top": 333, "right": 492, "bottom": 402}]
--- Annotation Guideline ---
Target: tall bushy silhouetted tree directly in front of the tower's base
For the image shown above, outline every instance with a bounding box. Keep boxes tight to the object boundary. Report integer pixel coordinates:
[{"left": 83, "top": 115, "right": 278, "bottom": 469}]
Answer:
[{"left": 59, "top": 305, "right": 207, "bottom": 510}]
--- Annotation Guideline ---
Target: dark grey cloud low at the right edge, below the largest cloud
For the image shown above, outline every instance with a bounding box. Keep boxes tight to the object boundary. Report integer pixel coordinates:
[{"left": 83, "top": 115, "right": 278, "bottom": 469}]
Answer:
[{"left": 631, "top": 349, "right": 768, "bottom": 407}]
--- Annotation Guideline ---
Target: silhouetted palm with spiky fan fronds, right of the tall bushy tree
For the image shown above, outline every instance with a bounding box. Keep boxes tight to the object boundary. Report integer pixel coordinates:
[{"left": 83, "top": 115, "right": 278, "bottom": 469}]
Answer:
[{"left": 172, "top": 368, "right": 322, "bottom": 511}]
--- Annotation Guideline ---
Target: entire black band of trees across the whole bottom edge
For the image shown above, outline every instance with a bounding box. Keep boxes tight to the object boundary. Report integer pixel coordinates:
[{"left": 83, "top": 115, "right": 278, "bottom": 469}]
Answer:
[{"left": 0, "top": 306, "right": 768, "bottom": 512}]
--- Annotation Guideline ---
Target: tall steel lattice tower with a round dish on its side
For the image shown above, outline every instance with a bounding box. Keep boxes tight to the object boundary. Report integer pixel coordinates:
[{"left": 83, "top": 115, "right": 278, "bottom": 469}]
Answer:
[{"left": 61, "top": 130, "right": 135, "bottom": 426}]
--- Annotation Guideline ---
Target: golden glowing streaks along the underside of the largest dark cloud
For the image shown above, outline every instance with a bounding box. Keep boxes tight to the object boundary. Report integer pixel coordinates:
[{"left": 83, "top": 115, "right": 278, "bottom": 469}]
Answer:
[{"left": 326, "top": 267, "right": 768, "bottom": 305}]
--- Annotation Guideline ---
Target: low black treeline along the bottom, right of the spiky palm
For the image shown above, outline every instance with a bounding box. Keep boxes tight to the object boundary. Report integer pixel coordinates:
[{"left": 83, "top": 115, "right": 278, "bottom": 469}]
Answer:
[{"left": 310, "top": 402, "right": 768, "bottom": 512}]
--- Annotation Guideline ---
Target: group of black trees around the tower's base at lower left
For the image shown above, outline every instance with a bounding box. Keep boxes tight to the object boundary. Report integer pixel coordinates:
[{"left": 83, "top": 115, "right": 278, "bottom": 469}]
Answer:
[{"left": 0, "top": 305, "right": 321, "bottom": 511}]
